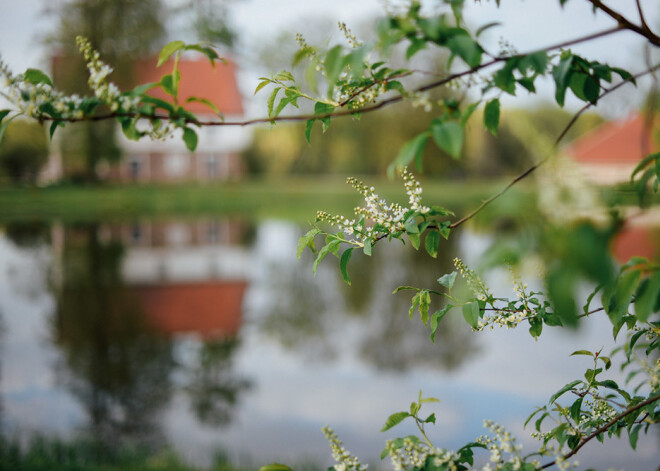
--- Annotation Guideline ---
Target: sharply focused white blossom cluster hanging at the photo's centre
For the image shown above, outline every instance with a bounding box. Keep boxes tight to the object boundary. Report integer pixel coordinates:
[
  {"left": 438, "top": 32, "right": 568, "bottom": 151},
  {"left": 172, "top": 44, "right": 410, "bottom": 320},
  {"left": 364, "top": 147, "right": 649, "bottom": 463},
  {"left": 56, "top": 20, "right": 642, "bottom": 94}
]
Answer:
[{"left": 316, "top": 167, "right": 430, "bottom": 245}]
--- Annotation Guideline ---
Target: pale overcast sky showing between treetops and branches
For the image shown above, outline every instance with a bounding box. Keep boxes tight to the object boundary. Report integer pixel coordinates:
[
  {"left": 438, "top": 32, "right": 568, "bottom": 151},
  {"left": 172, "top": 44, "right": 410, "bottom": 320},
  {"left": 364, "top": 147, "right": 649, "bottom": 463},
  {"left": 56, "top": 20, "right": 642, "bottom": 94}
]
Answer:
[{"left": 0, "top": 0, "right": 660, "bottom": 115}]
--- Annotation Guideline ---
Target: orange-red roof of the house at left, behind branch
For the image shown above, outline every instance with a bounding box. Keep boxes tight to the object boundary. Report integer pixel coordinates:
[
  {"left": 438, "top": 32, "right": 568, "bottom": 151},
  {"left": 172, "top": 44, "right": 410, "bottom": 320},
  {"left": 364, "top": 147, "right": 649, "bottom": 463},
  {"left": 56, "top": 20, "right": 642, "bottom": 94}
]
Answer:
[{"left": 134, "top": 56, "right": 243, "bottom": 115}]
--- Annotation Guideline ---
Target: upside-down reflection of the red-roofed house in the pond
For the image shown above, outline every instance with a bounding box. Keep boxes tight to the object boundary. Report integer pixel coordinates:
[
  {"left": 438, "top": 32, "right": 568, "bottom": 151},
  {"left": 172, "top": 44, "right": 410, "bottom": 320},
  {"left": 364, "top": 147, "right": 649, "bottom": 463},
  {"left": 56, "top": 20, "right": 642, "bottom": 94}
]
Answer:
[{"left": 53, "top": 220, "right": 250, "bottom": 339}]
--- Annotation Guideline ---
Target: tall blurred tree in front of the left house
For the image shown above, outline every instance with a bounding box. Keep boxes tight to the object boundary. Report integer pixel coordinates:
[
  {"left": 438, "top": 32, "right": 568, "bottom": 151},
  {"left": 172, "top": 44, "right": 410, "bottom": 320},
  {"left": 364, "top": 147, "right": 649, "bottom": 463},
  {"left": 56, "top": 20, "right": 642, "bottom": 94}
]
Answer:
[{"left": 46, "top": 0, "right": 165, "bottom": 181}]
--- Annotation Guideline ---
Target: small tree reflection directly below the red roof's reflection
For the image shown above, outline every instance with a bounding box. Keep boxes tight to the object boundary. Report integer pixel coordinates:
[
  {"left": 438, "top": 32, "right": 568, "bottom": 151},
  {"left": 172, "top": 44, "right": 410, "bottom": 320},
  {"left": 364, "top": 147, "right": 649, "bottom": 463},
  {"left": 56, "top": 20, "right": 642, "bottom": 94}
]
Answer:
[{"left": 187, "top": 338, "right": 250, "bottom": 426}]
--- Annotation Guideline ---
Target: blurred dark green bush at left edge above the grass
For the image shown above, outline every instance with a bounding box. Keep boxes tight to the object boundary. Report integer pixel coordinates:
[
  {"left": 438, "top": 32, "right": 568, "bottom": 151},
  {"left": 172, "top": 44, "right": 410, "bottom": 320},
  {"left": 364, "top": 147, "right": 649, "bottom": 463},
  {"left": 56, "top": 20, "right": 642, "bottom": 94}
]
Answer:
[{"left": 0, "top": 120, "right": 48, "bottom": 184}]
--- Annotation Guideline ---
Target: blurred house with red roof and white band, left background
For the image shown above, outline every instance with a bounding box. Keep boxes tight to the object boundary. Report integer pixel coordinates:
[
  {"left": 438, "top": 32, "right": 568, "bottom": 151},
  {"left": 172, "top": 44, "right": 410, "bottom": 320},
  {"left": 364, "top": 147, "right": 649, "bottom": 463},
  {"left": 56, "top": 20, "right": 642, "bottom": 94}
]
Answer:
[{"left": 46, "top": 54, "right": 250, "bottom": 183}]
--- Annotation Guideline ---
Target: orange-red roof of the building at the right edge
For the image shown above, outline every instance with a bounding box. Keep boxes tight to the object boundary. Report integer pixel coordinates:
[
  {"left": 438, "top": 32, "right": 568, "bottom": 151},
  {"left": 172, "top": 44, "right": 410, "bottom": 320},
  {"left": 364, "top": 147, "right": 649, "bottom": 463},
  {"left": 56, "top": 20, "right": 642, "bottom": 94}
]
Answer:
[{"left": 567, "top": 115, "right": 660, "bottom": 164}]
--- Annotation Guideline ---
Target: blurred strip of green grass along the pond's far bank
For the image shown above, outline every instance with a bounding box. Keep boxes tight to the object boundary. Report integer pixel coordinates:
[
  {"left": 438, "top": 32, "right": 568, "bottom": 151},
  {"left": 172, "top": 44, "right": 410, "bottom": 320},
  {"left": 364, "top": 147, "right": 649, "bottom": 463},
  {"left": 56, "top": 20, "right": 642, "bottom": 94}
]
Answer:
[{"left": 0, "top": 176, "right": 517, "bottom": 222}]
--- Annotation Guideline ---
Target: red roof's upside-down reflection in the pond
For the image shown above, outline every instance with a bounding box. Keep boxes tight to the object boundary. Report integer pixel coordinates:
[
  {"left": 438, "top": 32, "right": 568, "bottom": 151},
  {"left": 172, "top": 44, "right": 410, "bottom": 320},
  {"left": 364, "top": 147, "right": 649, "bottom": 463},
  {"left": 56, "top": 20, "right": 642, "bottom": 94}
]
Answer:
[{"left": 132, "top": 281, "right": 247, "bottom": 338}]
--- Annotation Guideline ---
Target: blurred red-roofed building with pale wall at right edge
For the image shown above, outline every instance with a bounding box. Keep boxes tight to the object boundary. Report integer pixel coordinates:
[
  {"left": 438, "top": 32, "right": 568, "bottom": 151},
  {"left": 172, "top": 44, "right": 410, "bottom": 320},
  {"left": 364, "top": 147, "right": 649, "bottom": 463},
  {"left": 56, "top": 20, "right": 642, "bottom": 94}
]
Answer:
[{"left": 566, "top": 115, "right": 660, "bottom": 185}]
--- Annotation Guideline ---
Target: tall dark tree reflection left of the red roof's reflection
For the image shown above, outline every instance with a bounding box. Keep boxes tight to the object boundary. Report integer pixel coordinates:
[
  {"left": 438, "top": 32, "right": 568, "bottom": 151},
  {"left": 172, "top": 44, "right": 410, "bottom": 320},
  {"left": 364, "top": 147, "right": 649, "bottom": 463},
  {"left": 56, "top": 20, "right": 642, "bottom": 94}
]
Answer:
[{"left": 54, "top": 225, "right": 174, "bottom": 450}]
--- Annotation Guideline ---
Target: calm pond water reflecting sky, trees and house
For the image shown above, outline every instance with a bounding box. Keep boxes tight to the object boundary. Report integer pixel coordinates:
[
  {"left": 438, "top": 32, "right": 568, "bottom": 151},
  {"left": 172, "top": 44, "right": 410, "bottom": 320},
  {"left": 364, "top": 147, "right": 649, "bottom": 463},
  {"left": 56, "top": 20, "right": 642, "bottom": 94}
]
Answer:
[{"left": 0, "top": 219, "right": 660, "bottom": 470}]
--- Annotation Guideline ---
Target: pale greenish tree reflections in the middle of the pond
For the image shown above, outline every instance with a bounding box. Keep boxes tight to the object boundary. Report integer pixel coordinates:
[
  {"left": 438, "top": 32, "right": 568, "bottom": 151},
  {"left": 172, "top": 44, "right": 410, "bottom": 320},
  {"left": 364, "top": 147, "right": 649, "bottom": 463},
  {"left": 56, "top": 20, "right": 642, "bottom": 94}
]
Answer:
[{"left": 255, "top": 228, "right": 476, "bottom": 370}]
